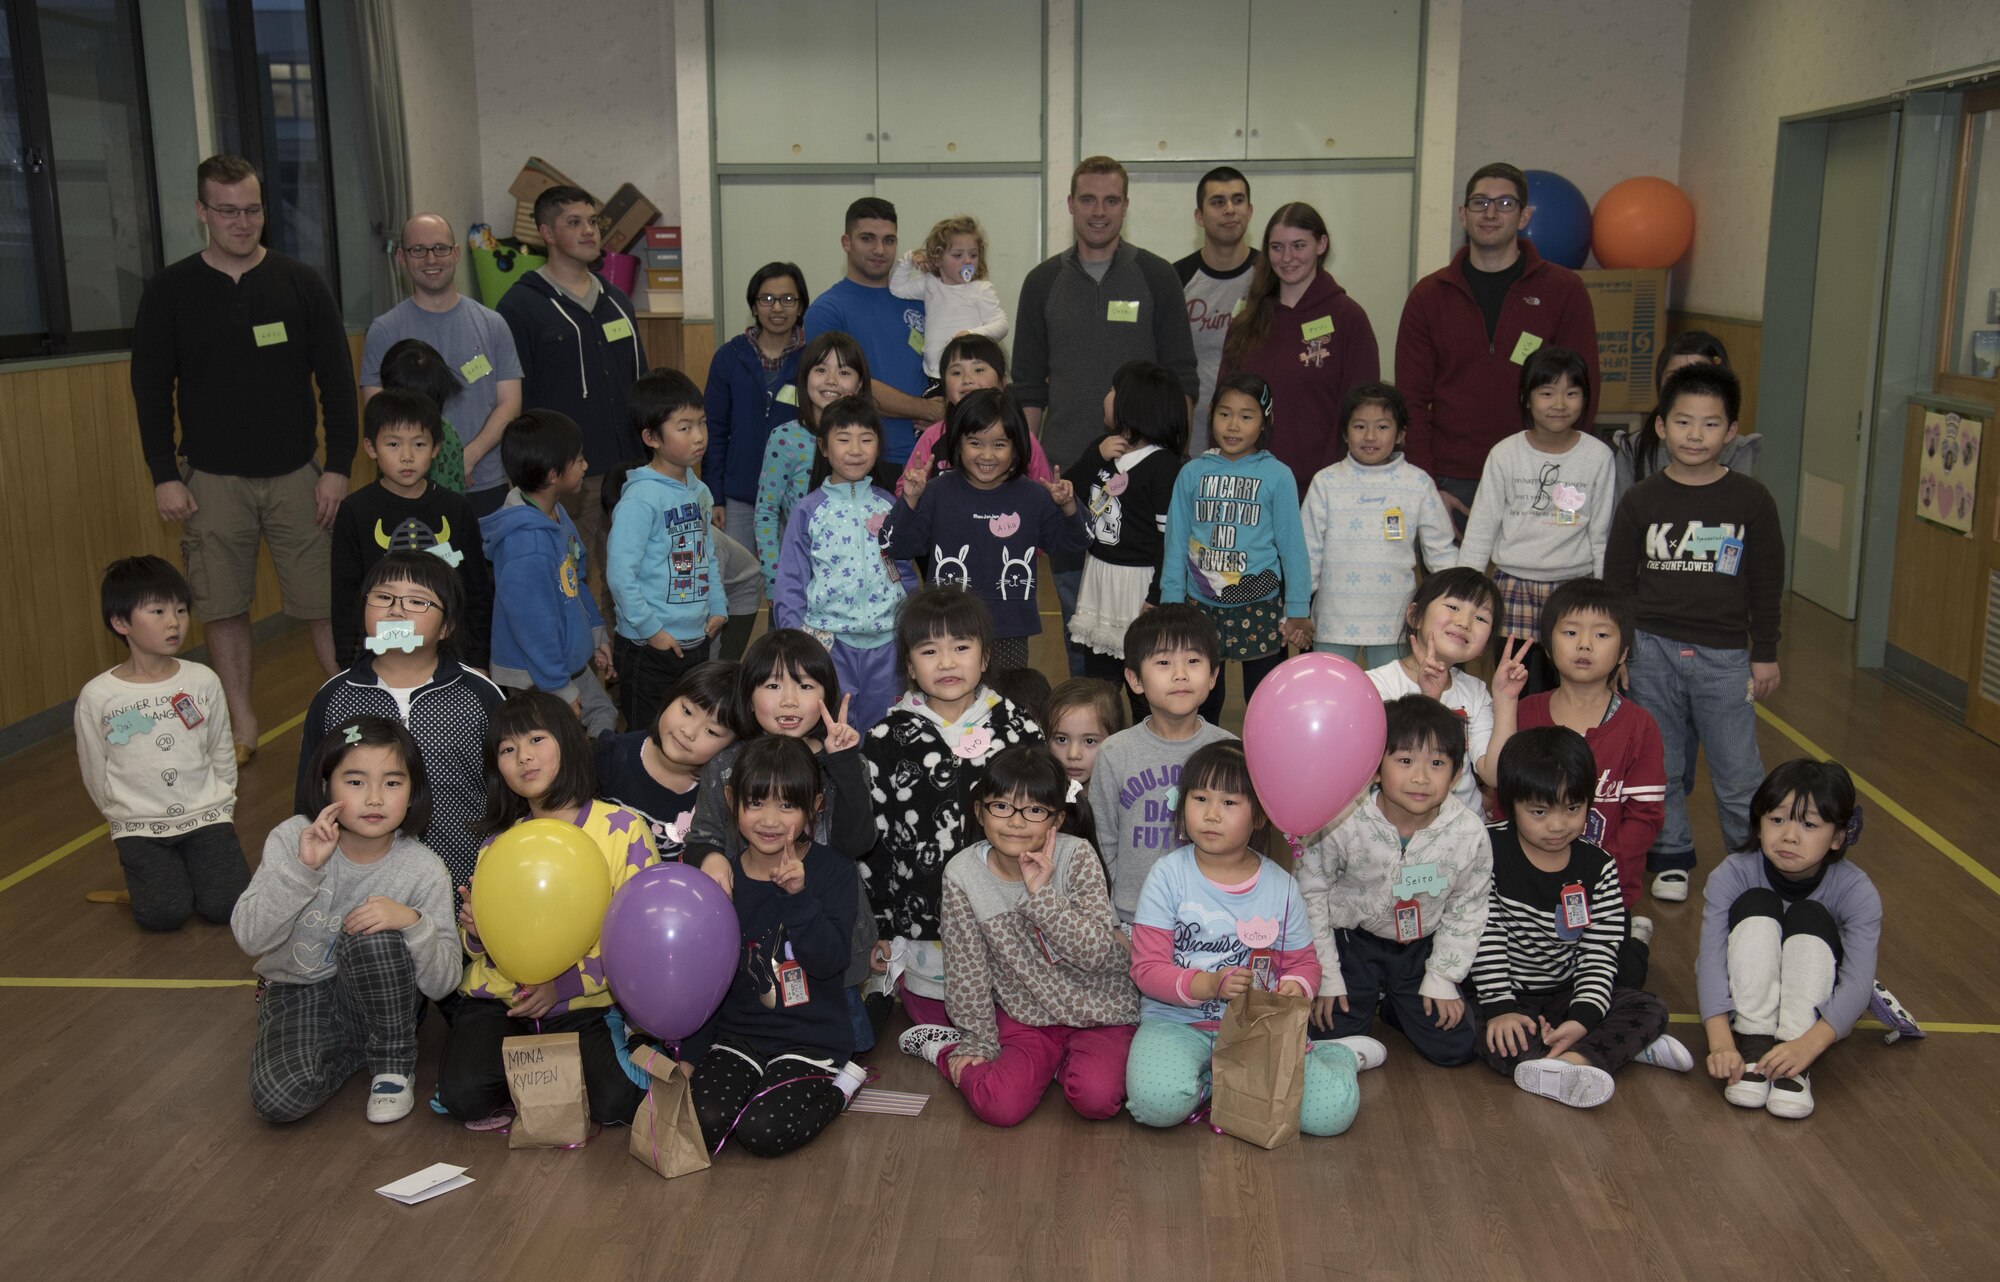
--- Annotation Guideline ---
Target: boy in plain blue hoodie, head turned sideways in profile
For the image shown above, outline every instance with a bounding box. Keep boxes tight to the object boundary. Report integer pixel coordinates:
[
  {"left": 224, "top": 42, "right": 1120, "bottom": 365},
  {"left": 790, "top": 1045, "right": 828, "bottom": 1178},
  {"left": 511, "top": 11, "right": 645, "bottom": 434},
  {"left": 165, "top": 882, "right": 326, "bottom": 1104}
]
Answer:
[{"left": 480, "top": 410, "right": 618, "bottom": 738}]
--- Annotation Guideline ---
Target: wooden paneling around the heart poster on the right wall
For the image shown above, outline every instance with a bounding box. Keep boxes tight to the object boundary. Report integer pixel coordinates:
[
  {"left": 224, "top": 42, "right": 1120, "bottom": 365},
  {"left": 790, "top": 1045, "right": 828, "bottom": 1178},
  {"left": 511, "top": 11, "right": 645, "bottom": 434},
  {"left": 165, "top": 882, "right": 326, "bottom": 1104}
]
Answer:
[{"left": 1888, "top": 404, "right": 1986, "bottom": 682}]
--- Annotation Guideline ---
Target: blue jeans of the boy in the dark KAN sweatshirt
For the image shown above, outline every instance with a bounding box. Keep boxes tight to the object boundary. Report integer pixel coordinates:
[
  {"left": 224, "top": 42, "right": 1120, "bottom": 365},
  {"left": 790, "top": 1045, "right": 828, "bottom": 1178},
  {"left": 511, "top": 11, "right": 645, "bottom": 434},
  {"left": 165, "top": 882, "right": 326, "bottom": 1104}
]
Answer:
[{"left": 1630, "top": 630, "right": 1764, "bottom": 872}]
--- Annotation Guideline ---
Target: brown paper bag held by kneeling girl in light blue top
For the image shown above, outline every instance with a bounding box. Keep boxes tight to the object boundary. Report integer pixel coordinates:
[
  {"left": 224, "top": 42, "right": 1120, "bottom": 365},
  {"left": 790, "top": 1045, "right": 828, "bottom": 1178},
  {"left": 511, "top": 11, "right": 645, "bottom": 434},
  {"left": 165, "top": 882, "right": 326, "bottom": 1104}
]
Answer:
[{"left": 1208, "top": 988, "right": 1312, "bottom": 1148}]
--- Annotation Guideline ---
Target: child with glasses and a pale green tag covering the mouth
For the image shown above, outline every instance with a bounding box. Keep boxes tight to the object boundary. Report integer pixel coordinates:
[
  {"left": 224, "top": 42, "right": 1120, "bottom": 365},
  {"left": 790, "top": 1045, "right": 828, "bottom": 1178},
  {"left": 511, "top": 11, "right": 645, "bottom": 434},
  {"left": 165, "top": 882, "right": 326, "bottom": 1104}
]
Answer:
[{"left": 294, "top": 552, "right": 504, "bottom": 886}]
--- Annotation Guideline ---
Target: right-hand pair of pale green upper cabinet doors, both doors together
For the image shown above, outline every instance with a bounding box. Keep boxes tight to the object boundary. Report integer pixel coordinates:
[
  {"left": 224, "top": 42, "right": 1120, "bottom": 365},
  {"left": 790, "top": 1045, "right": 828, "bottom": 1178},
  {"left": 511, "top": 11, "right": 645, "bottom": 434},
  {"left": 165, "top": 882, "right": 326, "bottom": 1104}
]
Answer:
[{"left": 1078, "top": 0, "right": 1424, "bottom": 162}]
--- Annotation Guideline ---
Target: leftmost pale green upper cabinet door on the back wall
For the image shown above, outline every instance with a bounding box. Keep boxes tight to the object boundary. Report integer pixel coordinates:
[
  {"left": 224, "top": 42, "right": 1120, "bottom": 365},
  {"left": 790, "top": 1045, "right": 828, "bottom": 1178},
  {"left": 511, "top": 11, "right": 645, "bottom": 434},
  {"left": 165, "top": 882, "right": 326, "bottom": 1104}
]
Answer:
[{"left": 712, "top": 0, "right": 876, "bottom": 166}]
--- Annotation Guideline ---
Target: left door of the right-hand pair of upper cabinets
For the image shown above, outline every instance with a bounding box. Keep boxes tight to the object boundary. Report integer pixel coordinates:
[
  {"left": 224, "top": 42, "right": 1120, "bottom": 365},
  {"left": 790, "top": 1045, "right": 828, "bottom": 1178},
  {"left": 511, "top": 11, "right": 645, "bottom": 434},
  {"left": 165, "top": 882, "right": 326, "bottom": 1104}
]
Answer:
[{"left": 1076, "top": 0, "right": 1250, "bottom": 162}]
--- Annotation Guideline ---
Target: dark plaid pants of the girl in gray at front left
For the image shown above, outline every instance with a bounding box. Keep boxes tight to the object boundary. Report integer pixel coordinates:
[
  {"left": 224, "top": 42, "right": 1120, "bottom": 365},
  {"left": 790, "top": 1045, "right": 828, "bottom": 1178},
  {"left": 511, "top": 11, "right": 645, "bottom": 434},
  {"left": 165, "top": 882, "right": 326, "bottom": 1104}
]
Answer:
[{"left": 250, "top": 930, "right": 424, "bottom": 1122}]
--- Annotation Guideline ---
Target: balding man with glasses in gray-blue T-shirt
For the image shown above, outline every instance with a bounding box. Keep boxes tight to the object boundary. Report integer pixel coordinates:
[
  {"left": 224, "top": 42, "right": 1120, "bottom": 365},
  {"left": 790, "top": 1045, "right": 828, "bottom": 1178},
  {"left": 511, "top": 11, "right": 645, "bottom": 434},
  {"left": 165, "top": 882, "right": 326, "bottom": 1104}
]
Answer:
[{"left": 362, "top": 214, "right": 520, "bottom": 516}]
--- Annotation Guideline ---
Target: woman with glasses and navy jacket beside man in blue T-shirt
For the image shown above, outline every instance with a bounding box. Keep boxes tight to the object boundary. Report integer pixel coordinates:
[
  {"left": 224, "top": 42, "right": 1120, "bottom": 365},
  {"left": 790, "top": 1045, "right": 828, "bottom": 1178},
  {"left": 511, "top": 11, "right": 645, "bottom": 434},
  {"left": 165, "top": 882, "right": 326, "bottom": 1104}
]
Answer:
[{"left": 702, "top": 262, "right": 812, "bottom": 548}]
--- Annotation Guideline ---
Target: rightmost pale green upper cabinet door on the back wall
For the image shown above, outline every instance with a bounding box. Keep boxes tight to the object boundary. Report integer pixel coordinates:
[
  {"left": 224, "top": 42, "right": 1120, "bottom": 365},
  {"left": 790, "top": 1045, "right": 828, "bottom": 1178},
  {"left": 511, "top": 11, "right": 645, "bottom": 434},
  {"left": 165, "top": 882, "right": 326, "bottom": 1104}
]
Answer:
[{"left": 1246, "top": 0, "right": 1424, "bottom": 160}]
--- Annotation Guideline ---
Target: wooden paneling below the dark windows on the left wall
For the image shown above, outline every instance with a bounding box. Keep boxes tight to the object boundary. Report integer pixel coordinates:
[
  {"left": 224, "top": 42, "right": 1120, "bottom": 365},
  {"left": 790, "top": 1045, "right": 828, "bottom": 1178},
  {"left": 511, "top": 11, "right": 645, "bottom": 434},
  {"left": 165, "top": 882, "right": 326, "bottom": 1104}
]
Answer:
[{"left": 0, "top": 334, "right": 374, "bottom": 726}]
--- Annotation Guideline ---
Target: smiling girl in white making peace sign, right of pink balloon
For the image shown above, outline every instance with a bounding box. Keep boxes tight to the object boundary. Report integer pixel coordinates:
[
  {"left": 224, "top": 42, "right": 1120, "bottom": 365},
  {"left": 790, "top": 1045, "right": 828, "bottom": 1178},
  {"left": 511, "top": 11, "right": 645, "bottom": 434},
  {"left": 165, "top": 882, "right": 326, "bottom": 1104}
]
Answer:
[{"left": 1368, "top": 566, "right": 1532, "bottom": 816}]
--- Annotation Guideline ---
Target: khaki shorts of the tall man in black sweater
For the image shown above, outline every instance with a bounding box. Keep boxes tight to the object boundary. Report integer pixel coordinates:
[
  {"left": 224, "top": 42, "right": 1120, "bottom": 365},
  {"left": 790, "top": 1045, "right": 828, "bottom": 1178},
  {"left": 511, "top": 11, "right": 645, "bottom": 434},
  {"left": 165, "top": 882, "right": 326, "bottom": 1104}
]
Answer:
[{"left": 180, "top": 464, "right": 332, "bottom": 620}]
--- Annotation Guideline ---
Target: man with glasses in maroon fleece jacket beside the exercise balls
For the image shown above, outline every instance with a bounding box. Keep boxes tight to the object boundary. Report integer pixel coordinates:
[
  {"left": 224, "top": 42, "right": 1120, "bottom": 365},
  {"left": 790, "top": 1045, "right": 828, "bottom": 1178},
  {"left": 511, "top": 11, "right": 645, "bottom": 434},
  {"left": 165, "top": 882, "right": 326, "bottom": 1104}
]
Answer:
[{"left": 1396, "top": 162, "right": 1598, "bottom": 532}]
